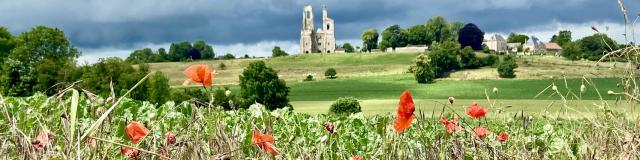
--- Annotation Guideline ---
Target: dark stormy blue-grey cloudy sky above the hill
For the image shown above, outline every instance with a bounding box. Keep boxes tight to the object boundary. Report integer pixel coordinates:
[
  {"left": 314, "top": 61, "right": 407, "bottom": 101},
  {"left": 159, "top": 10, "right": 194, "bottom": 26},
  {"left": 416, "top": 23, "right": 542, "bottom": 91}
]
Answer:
[{"left": 0, "top": 0, "right": 640, "bottom": 63}]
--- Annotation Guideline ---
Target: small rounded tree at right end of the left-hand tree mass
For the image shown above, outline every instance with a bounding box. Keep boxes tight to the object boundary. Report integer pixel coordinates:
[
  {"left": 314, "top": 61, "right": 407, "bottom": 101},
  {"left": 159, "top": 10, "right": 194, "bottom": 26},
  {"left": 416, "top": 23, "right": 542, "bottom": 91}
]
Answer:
[{"left": 147, "top": 72, "right": 171, "bottom": 104}]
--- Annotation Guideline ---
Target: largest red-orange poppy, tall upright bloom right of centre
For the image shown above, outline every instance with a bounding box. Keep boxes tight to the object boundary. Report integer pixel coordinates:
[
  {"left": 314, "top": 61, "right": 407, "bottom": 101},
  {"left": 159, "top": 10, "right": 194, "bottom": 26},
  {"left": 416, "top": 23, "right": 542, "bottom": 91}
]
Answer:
[{"left": 393, "top": 90, "right": 416, "bottom": 133}]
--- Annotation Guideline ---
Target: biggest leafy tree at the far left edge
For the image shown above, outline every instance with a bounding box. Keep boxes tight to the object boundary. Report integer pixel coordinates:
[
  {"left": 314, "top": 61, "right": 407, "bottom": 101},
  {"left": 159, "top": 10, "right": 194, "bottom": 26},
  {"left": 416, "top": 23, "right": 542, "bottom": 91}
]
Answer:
[{"left": 0, "top": 26, "right": 80, "bottom": 96}]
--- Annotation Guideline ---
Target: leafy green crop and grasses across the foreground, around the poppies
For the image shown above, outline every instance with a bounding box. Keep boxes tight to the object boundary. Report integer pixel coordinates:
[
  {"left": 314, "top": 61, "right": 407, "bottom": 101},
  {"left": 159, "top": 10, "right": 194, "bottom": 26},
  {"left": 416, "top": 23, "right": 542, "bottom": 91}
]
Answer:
[{"left": 0, "top": 94, "right": 640, "bottom": 159}]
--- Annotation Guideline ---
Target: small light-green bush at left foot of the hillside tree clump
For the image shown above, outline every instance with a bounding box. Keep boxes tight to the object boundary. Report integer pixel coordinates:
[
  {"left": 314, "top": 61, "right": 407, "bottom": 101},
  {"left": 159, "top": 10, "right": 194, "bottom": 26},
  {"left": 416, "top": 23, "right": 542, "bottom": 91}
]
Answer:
[{"left": 409, "top": 54, "right": 436, "bottom": 83}]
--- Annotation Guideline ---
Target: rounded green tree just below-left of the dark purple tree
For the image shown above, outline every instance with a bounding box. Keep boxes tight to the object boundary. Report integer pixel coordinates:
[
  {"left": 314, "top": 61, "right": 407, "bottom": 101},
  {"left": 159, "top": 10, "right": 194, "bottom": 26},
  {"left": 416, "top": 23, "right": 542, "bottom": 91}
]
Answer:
[{"left": 429, "top": 41, "right": 462, "bottom": 78}]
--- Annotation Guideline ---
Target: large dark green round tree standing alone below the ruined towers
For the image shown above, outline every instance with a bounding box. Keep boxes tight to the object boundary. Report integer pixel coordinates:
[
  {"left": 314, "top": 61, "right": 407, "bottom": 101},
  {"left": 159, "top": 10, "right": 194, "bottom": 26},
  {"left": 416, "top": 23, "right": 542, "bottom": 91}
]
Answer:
[{"left": 240, "top": 61, "right": 291, "bottom": 110}]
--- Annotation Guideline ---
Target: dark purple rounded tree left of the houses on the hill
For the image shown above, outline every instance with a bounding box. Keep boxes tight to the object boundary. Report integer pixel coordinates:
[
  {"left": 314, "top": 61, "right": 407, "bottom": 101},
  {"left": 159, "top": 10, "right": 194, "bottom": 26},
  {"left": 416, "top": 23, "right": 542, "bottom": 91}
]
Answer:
[{"left": 458, "top": 23, "right": 484, "bottom": 50}]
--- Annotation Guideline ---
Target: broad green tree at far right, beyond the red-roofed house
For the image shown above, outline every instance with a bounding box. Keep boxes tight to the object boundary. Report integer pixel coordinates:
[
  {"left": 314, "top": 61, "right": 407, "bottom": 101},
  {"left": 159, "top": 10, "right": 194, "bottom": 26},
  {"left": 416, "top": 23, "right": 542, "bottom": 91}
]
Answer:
[{"left": 578, "top": 33, "right": 617, "bottom": 61}]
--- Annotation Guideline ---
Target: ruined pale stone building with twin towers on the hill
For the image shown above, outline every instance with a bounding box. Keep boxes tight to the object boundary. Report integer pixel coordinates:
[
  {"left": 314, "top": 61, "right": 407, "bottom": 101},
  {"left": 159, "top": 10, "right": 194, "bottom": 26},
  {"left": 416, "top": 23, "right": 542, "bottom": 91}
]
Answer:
[{"left": 300, "top": 5, "right": 336, "bottom": 53}]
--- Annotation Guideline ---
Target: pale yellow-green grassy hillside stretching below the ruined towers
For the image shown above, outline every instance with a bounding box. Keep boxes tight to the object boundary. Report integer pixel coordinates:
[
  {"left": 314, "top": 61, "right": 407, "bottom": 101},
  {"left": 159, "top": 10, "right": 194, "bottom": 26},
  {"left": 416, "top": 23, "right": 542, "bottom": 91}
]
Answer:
[{"left": 149, "top": 53, "right": 623, "bottom": 86}]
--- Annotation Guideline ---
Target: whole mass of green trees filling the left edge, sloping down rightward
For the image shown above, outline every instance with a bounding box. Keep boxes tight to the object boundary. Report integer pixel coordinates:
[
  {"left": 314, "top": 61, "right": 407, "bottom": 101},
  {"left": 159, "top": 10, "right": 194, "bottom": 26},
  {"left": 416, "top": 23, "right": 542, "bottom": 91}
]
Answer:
[{"left": 0, "top": 26, "right": 171, "bottom": 103}]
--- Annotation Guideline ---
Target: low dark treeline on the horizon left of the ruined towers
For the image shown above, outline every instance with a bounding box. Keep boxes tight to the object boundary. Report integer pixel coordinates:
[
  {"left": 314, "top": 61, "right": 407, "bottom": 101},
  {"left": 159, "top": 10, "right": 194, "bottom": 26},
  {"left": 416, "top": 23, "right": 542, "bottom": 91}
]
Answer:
[{"left": 126, "top": 40, "right": 216, "bottom": 63}]
